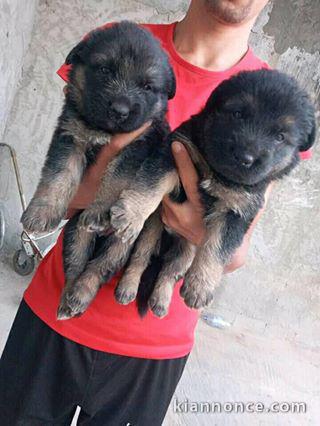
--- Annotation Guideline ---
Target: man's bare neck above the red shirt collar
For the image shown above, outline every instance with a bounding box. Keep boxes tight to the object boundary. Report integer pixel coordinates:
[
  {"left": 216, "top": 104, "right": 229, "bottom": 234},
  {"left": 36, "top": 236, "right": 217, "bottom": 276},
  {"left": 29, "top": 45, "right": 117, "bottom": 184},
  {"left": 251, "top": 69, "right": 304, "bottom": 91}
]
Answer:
[{"left": 173, "top": 3, "right": 254, "bottom": 71}]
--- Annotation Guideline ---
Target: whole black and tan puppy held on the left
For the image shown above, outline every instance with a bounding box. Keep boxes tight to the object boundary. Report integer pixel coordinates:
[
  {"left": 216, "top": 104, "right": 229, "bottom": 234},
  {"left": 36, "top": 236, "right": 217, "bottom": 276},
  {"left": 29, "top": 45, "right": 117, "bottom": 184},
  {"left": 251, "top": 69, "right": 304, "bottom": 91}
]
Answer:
[{"left": 21, "top": 22, "right": 175, "bottom": 318}]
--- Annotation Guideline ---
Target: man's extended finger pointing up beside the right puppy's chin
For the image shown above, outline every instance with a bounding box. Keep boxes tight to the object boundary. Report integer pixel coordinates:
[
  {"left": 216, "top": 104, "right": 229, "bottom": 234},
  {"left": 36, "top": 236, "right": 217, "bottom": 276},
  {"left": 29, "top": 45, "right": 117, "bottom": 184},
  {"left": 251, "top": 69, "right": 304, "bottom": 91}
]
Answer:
[{"left": 172, "top": 142, "right": 200, "bottom": 203}]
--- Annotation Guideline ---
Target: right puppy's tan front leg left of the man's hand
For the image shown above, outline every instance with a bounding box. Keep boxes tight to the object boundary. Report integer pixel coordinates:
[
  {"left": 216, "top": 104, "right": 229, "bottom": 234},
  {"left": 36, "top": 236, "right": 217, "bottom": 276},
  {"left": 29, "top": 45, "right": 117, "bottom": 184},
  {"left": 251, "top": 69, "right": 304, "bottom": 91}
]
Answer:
[{"left": 110, "top": 164, "right": 179, "bottom": 243}]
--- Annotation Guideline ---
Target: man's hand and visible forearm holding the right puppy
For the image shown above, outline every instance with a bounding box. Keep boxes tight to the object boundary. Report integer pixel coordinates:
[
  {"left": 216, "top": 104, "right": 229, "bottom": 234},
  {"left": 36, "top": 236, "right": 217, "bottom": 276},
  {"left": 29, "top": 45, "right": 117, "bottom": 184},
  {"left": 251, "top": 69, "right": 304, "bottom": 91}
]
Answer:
[{"left": 162, "top": 142, "right": 272, "bottom": 273}]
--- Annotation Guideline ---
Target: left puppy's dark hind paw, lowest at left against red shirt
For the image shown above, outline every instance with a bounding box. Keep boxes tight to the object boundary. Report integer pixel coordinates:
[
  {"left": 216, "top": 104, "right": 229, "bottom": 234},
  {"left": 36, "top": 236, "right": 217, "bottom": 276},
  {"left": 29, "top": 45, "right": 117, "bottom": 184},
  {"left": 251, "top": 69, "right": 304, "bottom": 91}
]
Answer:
[{"left": 57, "top": 285, "right": 92, "bottom": 320}]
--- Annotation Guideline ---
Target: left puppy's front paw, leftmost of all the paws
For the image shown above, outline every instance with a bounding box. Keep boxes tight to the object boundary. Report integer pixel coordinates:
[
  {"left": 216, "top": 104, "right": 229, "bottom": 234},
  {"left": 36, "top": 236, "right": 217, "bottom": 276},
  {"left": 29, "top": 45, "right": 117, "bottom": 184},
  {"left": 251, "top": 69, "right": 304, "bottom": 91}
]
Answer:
[{"left": 21, "top": 202, "right": 63, "bottom": 234}]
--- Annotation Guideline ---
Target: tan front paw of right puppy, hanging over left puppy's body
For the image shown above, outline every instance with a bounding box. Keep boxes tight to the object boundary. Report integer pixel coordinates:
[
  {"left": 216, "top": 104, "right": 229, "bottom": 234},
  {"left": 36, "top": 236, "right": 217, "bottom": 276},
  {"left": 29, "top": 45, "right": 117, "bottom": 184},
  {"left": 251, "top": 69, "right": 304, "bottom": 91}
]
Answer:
[{"left": 110, "top": 200, "right": 144, "bottom": 244}]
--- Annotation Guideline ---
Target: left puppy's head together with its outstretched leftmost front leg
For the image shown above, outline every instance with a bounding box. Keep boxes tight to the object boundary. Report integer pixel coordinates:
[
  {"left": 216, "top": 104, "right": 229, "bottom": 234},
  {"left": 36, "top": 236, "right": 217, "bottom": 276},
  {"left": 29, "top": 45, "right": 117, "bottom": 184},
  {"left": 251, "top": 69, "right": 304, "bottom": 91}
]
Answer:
[{"left": 21, "top": 22, "right": 175, "bottom": 233}]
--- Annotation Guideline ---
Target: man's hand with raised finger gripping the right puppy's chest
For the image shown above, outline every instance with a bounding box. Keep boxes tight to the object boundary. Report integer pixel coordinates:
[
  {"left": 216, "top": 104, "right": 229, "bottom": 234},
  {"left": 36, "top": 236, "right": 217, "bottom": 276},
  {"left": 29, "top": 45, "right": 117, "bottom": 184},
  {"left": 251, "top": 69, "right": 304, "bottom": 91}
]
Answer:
[{"left": 162, "top": 142, "right": 206, "bottom": 245}]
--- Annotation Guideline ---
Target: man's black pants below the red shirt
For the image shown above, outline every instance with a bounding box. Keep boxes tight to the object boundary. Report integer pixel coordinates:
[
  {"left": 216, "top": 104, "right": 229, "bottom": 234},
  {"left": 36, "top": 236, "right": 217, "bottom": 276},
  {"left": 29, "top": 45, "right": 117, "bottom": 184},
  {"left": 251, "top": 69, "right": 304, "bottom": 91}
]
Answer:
[{"left": 0, "top": 301, "right": 188, "bottom": 426}]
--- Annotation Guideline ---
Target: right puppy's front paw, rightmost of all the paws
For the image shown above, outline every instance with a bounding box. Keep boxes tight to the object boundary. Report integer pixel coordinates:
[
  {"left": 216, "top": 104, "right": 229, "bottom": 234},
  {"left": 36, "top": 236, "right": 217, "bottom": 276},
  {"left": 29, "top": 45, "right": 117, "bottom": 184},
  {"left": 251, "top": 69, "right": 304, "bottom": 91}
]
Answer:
[{"left": 180, "top": 274, "right": 214, "bottom": 309}]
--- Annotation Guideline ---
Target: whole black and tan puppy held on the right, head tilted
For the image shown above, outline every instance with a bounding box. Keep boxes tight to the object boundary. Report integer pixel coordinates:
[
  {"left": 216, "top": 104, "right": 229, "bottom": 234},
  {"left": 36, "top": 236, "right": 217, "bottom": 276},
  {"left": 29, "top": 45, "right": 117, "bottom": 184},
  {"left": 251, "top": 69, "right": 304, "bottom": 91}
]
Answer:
[{"left": 111, "top": 70, "right": 316, "bottom": 317}]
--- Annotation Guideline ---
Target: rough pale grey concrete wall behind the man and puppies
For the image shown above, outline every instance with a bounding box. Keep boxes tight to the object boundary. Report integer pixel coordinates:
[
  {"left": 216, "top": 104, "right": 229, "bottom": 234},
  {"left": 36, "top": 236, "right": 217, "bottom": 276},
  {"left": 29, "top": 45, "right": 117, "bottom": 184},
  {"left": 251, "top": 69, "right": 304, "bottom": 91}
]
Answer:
[{"left": 0, "top": 0, "right": 320, "bottom": 426}]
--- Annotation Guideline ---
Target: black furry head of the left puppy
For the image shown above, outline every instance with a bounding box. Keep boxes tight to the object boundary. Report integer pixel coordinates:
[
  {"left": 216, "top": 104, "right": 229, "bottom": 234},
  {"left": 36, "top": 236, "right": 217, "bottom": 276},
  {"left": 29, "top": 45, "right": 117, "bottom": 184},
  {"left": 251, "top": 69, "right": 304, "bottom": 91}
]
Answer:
[{"left": 66, "top": 21, "right": 175, "bottom": 134}]
